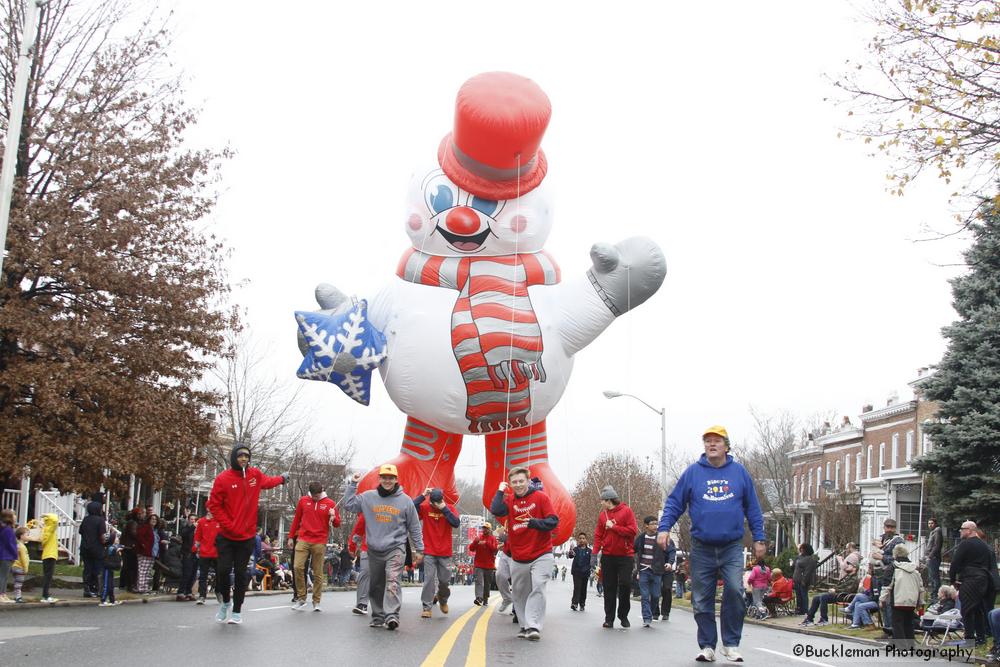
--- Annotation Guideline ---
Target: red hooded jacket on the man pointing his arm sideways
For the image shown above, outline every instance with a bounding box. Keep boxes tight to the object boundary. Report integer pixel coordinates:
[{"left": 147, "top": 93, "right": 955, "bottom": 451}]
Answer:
[{"left": 208, "top": 467, "right": 284, "bottom": 540}]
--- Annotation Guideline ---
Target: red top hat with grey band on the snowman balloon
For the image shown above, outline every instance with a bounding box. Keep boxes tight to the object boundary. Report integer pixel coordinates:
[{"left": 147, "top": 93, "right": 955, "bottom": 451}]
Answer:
[{"left": 438, "top": 72, "right": 552, "bottom": 200}]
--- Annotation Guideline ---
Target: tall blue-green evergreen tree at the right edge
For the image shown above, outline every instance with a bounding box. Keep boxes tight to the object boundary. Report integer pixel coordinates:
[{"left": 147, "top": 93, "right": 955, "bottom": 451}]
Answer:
[{"left": 914, "top": 199, "right": 1000, "bottom": 527}]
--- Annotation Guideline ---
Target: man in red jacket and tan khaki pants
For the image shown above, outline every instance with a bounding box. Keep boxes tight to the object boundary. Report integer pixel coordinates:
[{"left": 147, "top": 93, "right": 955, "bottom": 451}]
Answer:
[{"left": 288, "top": 482, "right": 340, "bottom": 611}]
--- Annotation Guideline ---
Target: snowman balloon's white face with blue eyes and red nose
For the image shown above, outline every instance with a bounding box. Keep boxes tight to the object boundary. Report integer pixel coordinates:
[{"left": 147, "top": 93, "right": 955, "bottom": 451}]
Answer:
[{"left": 406, "top": 169, "right": 552, "bottom": 257}]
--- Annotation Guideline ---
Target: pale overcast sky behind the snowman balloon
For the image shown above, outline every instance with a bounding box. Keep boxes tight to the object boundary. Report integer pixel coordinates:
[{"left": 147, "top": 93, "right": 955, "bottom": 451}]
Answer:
[{"left": 166, "top": 0, "right": 959, "bottom": 487}]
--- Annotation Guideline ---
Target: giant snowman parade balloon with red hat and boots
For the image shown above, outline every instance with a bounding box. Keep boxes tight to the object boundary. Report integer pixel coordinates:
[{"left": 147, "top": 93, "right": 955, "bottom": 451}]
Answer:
[{"left": 295, "top": 72, "right": 666, "bottom": 544}]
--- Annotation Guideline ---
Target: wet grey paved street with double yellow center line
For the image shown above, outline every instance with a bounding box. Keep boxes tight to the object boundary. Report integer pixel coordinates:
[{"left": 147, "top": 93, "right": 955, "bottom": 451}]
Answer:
[{"left": 0, "top": 581, "right": 964, "bottom": 667}]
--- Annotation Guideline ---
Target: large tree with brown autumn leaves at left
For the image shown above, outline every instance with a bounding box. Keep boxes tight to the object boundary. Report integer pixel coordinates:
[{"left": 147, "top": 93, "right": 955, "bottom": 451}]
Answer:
[{"left": 0, "top": 0, "right": 232, "bottom": 490}]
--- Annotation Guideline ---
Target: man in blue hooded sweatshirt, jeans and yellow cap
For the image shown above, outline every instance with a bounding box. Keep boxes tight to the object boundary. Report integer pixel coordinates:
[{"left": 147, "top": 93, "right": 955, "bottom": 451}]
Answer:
[{"left": 657, "top": 426, "right": 767, "bottom": 662}]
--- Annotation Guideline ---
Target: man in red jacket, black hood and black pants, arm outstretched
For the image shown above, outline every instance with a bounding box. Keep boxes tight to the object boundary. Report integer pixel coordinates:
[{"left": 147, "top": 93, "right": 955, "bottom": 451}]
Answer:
[{"left": 208, "top": 445, "right": 288, "bottom": 624}]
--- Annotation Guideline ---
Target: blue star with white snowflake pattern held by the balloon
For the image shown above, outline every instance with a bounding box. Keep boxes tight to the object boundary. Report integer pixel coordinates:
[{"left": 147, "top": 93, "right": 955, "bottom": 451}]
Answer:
[{"left": 295, "top": 299, "right": 387, "bottom": 405}]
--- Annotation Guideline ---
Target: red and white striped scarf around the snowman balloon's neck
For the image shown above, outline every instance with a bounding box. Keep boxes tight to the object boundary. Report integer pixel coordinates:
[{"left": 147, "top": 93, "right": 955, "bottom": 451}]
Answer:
[{"left": 396, "top": 248, "right": 559, "bottom": 433}]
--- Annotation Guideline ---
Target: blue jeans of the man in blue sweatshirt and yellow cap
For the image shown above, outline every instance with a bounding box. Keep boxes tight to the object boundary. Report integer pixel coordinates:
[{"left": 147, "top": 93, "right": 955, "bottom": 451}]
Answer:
[{"left": 690, "top": 539, "right": 746, "bottom": 650}]
